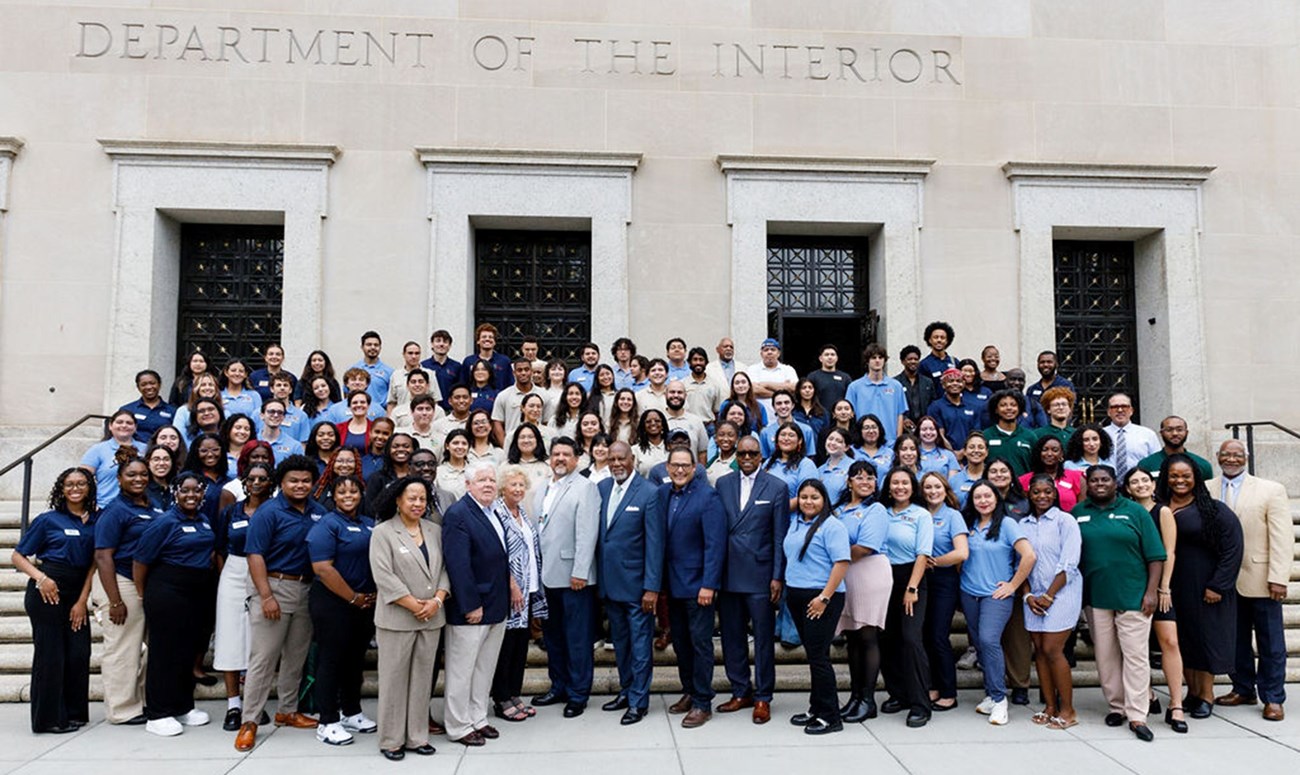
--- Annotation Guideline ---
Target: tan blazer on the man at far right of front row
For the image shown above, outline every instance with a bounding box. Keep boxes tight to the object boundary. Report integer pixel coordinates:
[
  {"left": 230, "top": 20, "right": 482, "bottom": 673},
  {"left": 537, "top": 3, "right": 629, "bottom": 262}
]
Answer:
[{"left": 1205, "top": 473, "right": 1295, "bottom": 597}]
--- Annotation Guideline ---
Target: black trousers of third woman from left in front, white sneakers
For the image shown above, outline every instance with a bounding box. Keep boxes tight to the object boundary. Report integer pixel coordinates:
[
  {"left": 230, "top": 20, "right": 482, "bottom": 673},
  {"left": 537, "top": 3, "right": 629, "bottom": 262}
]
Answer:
[{"left": 144, "top": 564, "right": 212, "bottom": 719}]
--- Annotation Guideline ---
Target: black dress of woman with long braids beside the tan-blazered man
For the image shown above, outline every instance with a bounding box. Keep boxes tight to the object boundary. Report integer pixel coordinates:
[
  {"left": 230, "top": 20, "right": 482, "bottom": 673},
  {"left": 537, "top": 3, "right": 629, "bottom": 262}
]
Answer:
[{"left": 1169, "top": 503, "right": 1242, "bottom": 675}]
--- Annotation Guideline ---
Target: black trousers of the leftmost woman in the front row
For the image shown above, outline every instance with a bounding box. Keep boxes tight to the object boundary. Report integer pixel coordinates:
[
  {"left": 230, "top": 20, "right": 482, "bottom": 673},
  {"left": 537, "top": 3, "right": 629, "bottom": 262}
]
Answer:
[{"left": 22, "top": 563, "right": 90, "bottom": 732}]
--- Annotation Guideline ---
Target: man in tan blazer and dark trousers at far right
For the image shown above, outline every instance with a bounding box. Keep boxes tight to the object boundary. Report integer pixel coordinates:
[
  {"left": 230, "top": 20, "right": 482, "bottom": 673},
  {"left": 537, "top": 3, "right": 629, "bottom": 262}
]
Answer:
[{"left": 1205, "top": 438, "right": 1295, "bottom": 722}]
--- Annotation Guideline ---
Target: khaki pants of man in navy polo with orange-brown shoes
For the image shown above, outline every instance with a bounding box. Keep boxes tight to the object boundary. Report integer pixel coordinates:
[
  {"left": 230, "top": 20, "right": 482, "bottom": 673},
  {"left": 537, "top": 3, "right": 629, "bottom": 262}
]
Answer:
[{"left": 243, "top": 579, "right": 312, "bottom": 724}]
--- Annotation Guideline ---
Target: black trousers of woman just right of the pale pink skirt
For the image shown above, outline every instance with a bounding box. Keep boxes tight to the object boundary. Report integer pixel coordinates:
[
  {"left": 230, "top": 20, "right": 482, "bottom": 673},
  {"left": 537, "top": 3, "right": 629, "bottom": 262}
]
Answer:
[{"left": 880, "top": 563, "right": 930, "bottom": 714}]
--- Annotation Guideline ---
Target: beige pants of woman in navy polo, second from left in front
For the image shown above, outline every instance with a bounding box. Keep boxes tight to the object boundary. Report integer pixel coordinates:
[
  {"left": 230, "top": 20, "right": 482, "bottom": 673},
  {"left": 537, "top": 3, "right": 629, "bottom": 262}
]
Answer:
[{"left": 91, "top": 572, "right": 144, "bottom": 724}]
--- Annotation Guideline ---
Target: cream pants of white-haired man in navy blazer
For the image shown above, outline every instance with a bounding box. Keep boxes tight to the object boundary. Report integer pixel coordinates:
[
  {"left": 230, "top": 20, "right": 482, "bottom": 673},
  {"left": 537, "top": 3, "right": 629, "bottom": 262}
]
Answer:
[{"left": 443, "top": 622, "right": 506, "bottom": 740}]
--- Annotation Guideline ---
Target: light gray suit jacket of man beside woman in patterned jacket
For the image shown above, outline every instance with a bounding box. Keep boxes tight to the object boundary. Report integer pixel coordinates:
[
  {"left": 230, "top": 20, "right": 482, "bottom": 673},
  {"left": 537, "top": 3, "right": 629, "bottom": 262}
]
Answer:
[{"left": 533, "top": 473, "right": 601, "bottom": 589}]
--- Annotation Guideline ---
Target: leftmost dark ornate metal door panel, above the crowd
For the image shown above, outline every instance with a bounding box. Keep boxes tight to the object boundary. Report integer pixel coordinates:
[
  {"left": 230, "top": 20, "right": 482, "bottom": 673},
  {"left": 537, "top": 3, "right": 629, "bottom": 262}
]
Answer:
[{"left": 177, "top": 224, "right": 285, "bottom": 368}]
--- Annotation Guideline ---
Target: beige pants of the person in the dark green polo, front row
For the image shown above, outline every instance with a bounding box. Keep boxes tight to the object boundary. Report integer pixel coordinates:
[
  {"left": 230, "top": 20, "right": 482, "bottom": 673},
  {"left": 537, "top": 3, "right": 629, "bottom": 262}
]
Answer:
[{"left": 1084, "top": 606, "right": 1151, "bottom": 724}]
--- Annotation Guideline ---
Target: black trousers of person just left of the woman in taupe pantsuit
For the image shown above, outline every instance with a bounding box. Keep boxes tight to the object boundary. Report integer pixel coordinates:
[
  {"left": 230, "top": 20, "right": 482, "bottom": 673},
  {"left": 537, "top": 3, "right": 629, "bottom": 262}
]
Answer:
[{"left": 307, "top": 580, "right": 374, "bottom": 724}]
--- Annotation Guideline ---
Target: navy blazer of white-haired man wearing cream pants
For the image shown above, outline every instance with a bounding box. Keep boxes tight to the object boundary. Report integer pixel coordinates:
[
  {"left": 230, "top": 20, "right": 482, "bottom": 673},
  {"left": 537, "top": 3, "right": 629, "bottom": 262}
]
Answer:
[{"left": 442, "top": 495, "right": 510, "bottom": 624}]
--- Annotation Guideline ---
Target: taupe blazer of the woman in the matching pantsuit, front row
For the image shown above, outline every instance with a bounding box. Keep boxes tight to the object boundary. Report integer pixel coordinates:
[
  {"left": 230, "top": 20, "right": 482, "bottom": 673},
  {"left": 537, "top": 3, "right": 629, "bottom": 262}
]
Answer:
[{"left": 371, "top": 516, "right": 451, "bottom": 631}]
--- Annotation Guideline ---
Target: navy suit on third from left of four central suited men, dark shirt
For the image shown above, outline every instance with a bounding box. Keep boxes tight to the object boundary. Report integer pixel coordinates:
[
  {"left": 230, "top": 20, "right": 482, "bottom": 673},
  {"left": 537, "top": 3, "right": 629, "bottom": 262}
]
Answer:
[{"left": 659, "top": 477, "right": 727, "bottom": 711}]
